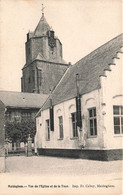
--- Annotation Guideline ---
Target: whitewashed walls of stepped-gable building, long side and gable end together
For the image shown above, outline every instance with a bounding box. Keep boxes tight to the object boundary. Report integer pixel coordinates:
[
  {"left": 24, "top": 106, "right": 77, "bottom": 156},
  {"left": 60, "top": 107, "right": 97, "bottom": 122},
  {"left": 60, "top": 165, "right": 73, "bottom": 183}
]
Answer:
[{"left": 36, "top": 51, "right": 123, "bottom": 149}]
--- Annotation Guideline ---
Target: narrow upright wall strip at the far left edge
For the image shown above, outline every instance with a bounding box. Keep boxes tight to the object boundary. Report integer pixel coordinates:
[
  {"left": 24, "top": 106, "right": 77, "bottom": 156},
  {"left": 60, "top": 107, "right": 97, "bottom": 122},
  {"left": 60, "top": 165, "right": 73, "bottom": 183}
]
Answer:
[{"left": 0, "top": 101, "right": 5, "bottom": 172}]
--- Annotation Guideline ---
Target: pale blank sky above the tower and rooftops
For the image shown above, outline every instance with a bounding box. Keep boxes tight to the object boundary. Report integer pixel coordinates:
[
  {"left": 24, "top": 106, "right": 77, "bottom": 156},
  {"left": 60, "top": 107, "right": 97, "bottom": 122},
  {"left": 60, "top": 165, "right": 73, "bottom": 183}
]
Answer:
[{"left": 0, "top": 0, "right": 122, "bottom": 91}]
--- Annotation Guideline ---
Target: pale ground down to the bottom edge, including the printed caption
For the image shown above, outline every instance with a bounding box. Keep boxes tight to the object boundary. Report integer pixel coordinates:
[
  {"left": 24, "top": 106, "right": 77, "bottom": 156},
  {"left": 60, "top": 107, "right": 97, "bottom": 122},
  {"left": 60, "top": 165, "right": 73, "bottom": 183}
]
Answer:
[{"left": 0, "top": 156, "right": 123, "bottom": 195}]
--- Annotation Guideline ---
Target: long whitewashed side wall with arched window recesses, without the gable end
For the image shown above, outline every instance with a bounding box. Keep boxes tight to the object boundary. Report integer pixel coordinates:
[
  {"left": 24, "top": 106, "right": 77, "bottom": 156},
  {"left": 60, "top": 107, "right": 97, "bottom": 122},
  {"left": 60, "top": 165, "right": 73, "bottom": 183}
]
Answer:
[{"left": 36, "top": 90, "right": 103, "bottom": 149}]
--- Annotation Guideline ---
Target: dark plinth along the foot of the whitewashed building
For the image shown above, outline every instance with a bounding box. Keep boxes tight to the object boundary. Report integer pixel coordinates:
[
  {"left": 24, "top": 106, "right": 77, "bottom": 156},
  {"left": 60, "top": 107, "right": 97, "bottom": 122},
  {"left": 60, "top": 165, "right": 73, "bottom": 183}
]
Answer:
[{"left": 37, "top": 148, "right": 123, "bottom": 161}]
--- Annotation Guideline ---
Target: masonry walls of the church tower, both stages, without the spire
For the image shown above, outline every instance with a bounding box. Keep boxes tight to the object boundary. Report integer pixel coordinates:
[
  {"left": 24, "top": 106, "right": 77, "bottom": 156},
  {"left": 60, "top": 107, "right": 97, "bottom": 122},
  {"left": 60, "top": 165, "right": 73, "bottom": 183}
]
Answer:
[{"left": 21, "top": 30, "right": 67, "bottom": 94}]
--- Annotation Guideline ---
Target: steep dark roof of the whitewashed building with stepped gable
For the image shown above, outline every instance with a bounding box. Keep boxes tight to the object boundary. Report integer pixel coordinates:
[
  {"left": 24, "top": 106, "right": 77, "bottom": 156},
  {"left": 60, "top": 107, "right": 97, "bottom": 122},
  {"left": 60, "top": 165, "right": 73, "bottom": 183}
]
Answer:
[{"left": 42, "top": 34, "right": 123, "bottom": 110}]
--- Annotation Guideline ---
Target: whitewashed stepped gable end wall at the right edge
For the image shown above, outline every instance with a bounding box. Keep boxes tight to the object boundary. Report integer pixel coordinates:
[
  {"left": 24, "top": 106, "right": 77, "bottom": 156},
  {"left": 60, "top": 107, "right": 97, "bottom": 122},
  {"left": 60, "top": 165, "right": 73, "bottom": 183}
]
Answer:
[{"left": 101, "top": 53, "right": 123, "bottom": 149}]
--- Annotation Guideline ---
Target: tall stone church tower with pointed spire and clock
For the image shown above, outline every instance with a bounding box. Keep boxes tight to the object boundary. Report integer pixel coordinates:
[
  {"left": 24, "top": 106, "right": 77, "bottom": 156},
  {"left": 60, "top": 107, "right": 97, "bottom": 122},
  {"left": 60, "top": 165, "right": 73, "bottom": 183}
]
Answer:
[{"left": 21, "top": 8, "right": 68, "bottom": 94}]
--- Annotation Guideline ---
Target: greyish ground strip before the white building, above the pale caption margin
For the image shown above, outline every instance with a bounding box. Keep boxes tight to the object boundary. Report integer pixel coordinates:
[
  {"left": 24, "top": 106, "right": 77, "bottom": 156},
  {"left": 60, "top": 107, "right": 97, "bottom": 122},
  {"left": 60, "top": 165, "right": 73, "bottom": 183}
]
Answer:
[{"left": 6, "top": 156, "right": 122, "bottom": 176}]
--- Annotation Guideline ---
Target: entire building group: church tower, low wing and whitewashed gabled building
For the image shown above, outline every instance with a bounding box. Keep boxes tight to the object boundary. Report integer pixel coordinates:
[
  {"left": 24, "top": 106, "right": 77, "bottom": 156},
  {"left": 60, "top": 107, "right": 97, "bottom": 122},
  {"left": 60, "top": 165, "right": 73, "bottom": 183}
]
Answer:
[{"left": 0, "top": 6, "right": 123, "bottom": 160}]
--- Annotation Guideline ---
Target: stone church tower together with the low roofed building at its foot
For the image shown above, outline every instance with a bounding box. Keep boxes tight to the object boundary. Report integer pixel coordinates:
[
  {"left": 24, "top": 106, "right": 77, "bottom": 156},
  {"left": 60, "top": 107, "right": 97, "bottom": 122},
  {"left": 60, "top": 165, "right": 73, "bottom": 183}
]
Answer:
[{"left": 0, "top": 13, "right": 69, "bottom": 152}]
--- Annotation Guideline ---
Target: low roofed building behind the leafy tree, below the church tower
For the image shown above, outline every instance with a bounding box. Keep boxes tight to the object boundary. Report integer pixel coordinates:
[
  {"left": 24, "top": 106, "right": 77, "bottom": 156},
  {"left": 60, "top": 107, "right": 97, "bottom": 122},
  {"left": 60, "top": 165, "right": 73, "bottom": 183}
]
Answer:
[{"left": 0, "top": 91, "right": 48, "bottom": 153}]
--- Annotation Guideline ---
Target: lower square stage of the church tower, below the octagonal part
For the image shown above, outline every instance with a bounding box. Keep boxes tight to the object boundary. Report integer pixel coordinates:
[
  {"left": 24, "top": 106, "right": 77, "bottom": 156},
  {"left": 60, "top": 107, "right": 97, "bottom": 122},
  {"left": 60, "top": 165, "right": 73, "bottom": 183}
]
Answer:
[{"left": 23, "top": 61, "right": 68, "bottom": 94}]
